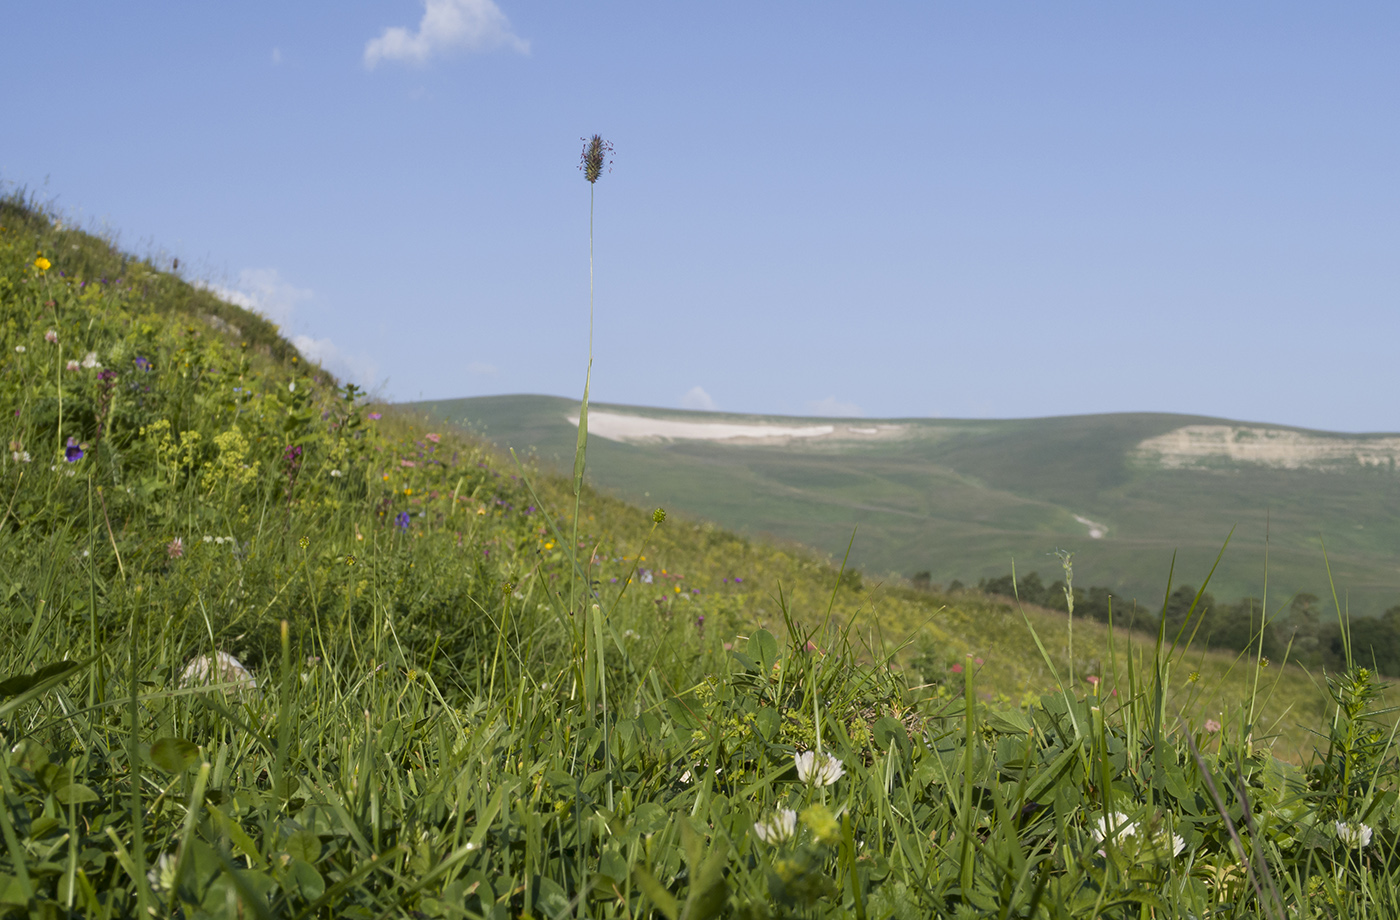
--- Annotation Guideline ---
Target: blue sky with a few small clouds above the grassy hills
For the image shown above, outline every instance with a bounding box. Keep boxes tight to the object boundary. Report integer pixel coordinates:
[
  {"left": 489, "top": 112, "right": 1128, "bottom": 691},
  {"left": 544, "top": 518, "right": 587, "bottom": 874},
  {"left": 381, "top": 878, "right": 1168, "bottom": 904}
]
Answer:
[{"left": 0, "top": 0, "right": 1400, "bottom": 431}]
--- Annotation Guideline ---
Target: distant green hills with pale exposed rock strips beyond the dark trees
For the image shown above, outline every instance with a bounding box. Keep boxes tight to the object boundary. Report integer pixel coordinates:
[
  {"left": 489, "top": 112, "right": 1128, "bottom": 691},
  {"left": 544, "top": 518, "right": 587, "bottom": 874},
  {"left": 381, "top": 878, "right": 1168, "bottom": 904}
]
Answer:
[{"left": 407, "top": 395, "right": 1400, "bottom": 615}]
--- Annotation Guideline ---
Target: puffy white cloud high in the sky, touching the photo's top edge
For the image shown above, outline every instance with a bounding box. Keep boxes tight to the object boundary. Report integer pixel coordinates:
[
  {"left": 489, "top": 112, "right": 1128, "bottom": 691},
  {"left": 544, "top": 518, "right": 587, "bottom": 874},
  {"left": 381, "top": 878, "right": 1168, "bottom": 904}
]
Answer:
[{"left": 364, "top": 0, "right": 529, "bottom": 70}]
